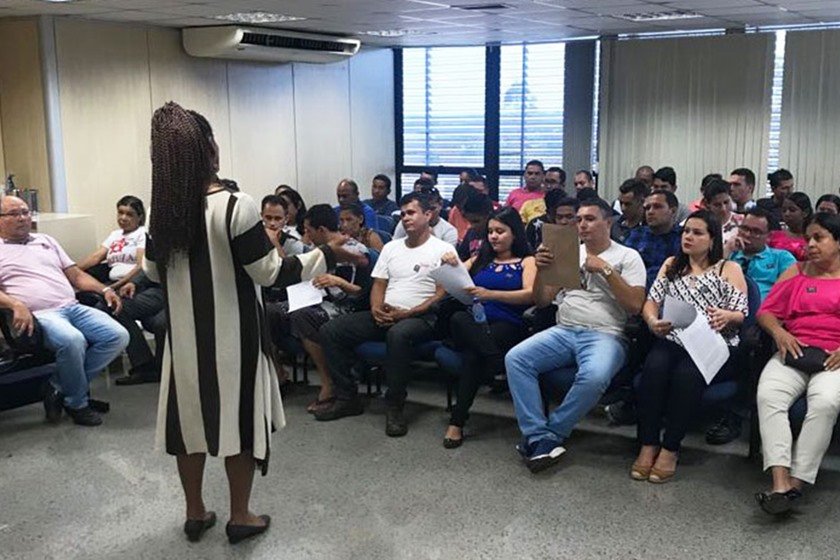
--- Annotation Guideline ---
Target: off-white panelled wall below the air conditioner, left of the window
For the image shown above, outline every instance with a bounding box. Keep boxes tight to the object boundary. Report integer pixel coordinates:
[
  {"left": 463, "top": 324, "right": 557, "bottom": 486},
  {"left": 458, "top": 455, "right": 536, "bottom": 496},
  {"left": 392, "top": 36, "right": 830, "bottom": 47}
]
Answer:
[{"left": 50, "top": 19, "right": 394, "bottom": 243}]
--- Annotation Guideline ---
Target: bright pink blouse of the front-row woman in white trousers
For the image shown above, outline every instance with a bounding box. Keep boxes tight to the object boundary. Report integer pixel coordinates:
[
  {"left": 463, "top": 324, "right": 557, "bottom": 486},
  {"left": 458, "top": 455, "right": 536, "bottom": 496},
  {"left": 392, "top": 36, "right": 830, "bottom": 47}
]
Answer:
[{"left": 758, "top": 269, "right": 840, "bottom": 352}]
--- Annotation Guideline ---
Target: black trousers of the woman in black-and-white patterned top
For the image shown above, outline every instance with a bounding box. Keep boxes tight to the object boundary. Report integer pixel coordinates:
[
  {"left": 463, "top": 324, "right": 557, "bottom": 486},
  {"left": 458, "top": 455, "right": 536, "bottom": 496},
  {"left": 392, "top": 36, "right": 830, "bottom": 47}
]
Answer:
[{"left": 636, "top": 338, "right": 737, "bottom": 452}]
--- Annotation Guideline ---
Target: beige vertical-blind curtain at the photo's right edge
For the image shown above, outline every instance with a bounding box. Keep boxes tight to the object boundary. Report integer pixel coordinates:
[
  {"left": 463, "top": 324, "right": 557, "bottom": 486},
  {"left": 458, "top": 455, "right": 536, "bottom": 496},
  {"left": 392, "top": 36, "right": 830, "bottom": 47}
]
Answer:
[{"left": 779, "top": 30, "right": 840, "bottom": 203}]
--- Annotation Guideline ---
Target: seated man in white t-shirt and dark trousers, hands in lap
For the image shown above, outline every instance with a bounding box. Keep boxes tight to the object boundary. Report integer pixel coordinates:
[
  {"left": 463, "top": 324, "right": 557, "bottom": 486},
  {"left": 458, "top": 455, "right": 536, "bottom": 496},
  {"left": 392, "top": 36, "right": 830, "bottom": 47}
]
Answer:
[{"left": 315, "top": 192, "right": 452, "bottom": 437}]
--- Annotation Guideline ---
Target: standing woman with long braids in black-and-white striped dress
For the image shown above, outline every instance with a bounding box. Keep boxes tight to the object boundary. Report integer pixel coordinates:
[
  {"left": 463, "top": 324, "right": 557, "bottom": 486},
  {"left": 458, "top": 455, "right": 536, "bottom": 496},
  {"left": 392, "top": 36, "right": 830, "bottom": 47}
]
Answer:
[{"left": 143, "top": 102, "right": 343, "bottom": 544}]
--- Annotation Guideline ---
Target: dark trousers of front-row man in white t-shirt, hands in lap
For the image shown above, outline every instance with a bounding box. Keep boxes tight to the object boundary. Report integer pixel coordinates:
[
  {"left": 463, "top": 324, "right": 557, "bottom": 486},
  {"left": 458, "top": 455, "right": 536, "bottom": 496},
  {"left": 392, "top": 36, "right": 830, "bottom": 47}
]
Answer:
[{"left": 320, "top": 311, "right": 435, "bottom": 406}]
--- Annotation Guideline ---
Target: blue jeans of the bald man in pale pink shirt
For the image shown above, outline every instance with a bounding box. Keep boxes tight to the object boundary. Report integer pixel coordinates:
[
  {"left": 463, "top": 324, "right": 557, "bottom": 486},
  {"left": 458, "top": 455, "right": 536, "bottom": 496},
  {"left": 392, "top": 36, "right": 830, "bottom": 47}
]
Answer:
[{"left": 34, "top": 303, "right": 128, "bottom": 409}]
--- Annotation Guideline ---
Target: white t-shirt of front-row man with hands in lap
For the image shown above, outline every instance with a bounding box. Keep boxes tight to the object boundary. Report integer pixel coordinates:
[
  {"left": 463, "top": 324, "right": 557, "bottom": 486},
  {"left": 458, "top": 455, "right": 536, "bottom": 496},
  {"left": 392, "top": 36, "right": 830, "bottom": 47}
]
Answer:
[{"left": 371, "top": 236, "right": 452, "bottom": 309}]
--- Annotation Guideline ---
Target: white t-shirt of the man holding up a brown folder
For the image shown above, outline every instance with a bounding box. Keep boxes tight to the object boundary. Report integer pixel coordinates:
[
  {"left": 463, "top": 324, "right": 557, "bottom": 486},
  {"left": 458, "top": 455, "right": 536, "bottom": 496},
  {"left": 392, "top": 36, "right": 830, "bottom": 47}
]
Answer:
[{"left": 556, "top": 241, "right": 647, "bottom": 336}]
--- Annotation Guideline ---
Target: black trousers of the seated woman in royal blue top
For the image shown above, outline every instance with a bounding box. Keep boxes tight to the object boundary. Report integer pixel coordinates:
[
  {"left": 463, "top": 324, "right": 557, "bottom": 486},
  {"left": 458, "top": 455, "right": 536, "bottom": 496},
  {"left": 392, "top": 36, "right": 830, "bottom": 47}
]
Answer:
[{"left": 449, "top": 311, "right": 525, "bottom": 427}]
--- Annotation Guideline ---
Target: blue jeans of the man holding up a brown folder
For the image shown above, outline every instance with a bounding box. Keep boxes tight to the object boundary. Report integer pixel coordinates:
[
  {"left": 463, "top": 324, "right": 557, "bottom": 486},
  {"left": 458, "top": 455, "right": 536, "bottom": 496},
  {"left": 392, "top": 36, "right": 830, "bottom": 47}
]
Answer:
[{"left": 505, "top": 326, "right": 627, "bottom": 443}]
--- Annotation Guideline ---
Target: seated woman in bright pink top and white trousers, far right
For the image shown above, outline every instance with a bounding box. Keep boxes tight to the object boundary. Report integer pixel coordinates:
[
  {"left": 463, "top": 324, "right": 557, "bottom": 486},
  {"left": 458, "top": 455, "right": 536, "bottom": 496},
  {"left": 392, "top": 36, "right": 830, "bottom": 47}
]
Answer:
[{"left": 756, "top": 213, "right": 840, "bottom": 514}]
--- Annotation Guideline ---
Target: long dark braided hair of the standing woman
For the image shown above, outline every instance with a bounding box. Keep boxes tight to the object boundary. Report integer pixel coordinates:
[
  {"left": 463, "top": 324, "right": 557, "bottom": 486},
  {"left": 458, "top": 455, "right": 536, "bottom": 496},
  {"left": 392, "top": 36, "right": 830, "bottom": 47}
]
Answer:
[{"left": 149, "top": 101, "right": 218, "bottom": 266}]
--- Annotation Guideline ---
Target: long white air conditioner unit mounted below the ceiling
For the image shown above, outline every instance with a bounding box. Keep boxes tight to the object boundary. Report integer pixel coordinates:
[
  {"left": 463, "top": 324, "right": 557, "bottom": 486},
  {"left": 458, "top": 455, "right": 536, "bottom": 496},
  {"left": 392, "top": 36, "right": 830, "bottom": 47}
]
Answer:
[{"left": 182, "top": 25, "right": 361, "bottom": 63}]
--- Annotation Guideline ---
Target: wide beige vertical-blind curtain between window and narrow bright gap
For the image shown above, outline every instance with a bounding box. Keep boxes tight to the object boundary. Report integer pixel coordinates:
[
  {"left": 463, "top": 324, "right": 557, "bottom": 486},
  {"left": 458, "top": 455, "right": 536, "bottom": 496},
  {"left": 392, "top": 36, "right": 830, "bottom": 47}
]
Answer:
[{"left": 599, "top": 33, "right": 774, "bottom": 202}]
